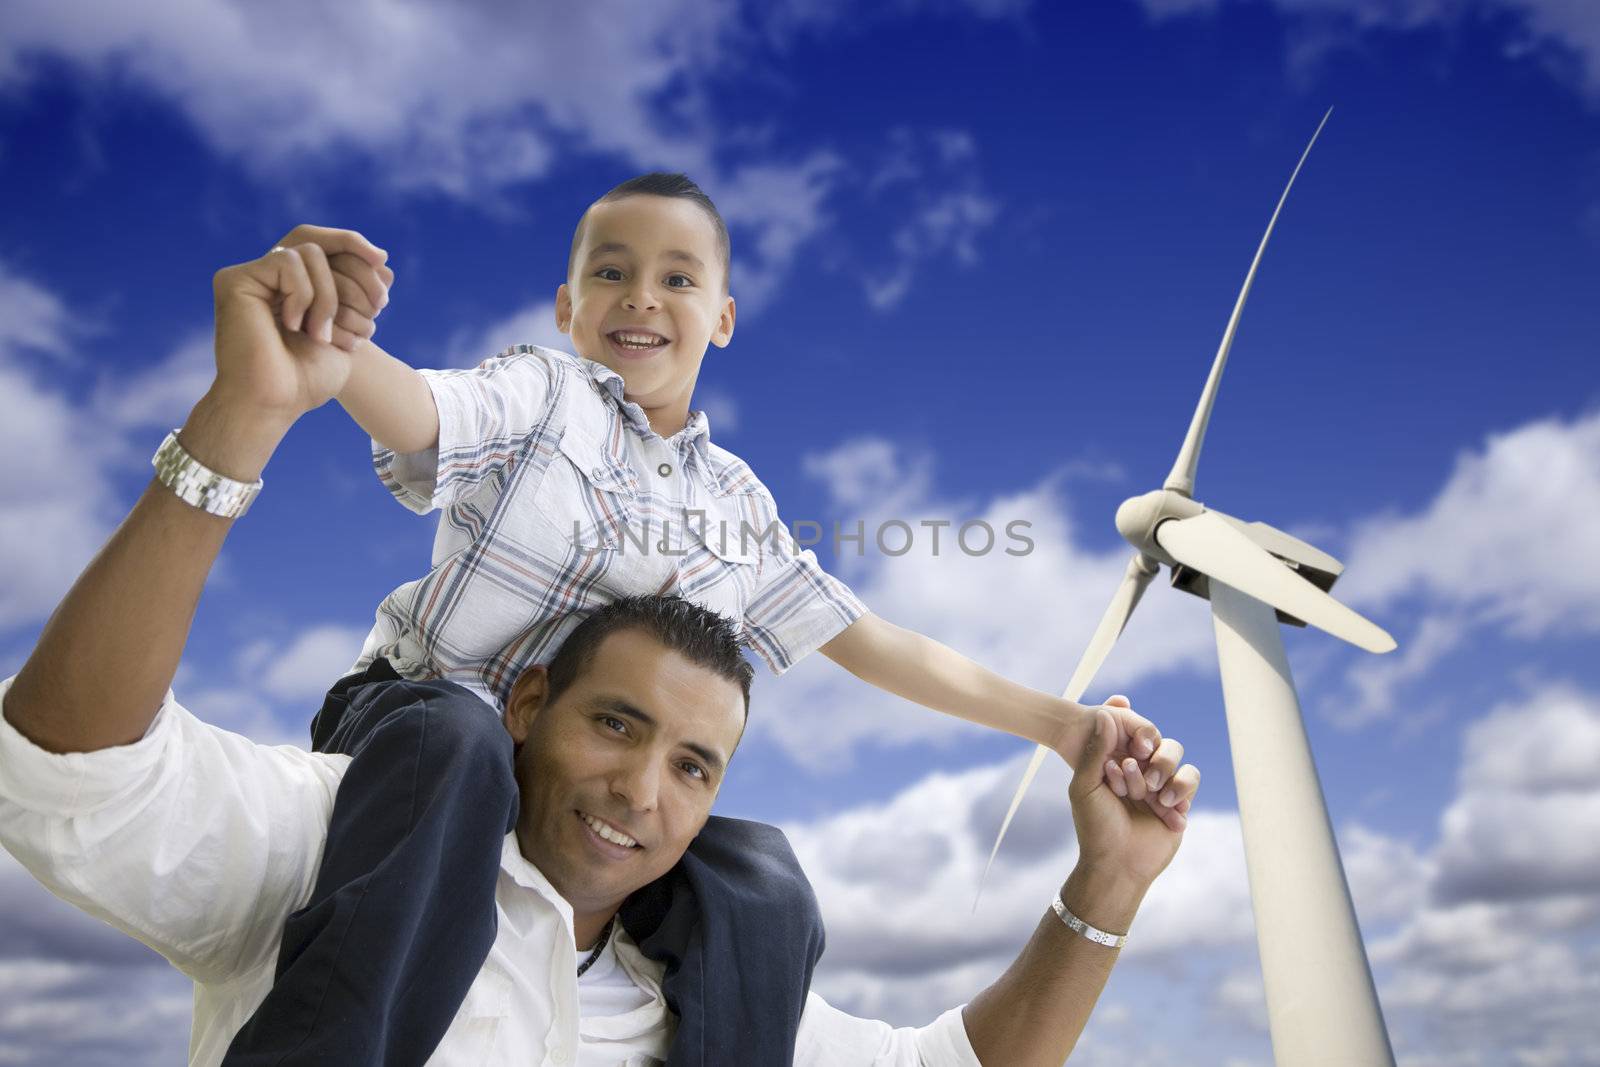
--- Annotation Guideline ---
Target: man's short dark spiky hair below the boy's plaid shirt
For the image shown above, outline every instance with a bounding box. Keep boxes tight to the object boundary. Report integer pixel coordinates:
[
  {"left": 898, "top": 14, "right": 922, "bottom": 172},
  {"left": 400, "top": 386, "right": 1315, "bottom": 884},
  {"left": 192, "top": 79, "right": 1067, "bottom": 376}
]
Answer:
[{"left": 546, "top": 595, "right": 755, "bottom": 718}]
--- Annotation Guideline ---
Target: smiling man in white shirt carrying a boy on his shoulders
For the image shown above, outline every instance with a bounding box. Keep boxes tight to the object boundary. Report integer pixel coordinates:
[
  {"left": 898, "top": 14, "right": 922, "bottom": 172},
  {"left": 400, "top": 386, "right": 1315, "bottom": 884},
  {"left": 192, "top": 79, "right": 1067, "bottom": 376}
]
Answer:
[{"left": 0, "top": 235, "right": 1197, "bottom": 1064}]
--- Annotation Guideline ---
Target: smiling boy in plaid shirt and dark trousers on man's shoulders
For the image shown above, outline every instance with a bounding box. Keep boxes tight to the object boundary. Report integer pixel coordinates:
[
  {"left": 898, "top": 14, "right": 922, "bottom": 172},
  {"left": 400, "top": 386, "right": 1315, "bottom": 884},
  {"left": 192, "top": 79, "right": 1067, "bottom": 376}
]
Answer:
[{"left": 219, "top": 174, "right": 1187, "bottom": 1062}]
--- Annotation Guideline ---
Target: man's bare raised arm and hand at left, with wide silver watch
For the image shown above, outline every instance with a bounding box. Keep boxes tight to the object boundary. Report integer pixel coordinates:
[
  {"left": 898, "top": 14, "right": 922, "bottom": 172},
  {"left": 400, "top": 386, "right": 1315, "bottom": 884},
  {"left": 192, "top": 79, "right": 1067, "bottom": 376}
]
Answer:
[{"left": 5, "top": 230, "right": 382, "bottom": 752}]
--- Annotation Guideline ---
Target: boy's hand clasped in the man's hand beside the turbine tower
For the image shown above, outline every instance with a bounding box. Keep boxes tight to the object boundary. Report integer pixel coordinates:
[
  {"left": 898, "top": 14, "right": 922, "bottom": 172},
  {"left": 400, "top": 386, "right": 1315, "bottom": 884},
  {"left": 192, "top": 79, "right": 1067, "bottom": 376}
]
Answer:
[{"left": 1056, "top": 696, "right": 1200, "bottom": 830}]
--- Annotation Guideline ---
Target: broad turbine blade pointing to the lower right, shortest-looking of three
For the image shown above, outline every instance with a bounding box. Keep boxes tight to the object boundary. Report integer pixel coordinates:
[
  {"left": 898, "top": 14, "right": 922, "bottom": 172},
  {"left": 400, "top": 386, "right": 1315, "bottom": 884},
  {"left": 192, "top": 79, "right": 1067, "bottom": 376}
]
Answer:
[{"left": 1155, "top": 512, "right": 1395, "bottom": 653}]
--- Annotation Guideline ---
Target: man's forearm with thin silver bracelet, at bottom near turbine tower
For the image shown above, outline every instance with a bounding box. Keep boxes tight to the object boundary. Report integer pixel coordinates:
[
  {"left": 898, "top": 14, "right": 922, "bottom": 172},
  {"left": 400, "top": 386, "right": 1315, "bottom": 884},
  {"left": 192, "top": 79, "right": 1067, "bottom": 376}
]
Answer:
[{"left": 962, "top": 867, "right": 1149, "bottom": 1067}]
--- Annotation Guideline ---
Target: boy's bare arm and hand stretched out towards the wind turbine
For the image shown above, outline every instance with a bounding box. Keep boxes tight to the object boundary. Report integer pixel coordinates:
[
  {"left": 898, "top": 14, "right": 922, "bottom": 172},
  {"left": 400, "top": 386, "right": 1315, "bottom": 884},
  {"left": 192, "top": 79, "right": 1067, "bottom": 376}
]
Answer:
[{"left": 821, "top": 613, "right": 1187, "bottom": 822}]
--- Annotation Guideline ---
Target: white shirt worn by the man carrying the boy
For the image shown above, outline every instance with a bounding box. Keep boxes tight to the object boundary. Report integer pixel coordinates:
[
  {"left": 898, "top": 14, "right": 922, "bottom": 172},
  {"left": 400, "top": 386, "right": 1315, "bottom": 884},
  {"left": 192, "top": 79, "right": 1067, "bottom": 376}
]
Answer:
[{"left": 0, "top": 678, "right": 978, "bottom": 1067}]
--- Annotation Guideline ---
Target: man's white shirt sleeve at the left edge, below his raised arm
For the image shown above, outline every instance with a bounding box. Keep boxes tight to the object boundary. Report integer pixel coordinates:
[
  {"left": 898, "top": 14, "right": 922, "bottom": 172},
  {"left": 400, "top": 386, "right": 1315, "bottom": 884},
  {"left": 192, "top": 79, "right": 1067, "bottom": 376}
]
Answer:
[{"left": 0, "top": 680, "right": 349, "bottom": 982}]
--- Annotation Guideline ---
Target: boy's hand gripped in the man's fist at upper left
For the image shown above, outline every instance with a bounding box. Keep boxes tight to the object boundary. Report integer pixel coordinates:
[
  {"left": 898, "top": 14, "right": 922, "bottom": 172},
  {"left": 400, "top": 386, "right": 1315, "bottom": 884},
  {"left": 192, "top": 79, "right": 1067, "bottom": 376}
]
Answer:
[{"left": 267, "top": 226, "right": 395, "bottom": 352}]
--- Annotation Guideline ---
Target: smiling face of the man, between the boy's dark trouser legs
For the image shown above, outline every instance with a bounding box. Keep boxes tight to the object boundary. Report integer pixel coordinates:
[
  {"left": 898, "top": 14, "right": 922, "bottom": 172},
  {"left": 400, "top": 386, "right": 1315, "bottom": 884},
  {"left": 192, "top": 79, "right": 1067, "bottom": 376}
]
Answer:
[{"left": 506, "top": 630, "right": 744, "bottom": 915}]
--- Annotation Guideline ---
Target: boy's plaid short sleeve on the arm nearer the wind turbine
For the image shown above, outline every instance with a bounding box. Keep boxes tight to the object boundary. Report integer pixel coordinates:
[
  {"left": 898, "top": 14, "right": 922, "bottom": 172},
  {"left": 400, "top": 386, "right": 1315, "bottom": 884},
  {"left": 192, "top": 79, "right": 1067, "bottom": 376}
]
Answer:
[{"left": 744, "top": 490, "right": 867, "bottom": 675}]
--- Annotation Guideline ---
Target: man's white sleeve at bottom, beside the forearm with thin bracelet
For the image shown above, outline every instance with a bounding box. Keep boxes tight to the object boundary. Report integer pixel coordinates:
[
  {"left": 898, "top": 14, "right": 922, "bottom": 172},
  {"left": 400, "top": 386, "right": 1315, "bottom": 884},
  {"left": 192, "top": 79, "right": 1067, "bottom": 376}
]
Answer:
[{"left": 795, "top": 993, "right": 982, "bottom": 1067}]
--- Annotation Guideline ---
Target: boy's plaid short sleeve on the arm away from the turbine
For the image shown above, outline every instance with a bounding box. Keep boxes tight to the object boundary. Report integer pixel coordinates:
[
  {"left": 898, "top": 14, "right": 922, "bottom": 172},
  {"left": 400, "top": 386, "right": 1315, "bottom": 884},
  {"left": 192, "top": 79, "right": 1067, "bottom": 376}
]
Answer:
[{"left": 373, "top": 344, "right": 557, "bottom": 515}]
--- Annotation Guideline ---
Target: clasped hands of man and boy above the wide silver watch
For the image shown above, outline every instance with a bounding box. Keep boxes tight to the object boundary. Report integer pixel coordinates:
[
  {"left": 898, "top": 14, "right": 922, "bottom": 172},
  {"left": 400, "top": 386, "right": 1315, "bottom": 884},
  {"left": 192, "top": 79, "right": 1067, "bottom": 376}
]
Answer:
[{"left": 211, "top": 226, "right": 394, "bottom": 426}]
